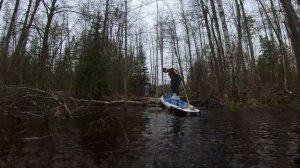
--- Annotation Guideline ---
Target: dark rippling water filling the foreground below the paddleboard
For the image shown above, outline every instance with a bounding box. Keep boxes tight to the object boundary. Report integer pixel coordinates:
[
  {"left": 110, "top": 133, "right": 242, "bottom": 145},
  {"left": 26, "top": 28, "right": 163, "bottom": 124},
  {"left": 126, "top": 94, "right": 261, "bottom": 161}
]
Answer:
[{"left": 0, "top": 104, "right": 300, "bottom": 168}]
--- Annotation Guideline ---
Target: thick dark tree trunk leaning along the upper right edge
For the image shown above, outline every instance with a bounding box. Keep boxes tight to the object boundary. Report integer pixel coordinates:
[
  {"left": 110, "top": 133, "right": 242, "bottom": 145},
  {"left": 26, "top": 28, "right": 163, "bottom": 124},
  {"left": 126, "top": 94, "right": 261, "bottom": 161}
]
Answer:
[{"left": 280, "top": 0, "right": 300, "bottom": 82}]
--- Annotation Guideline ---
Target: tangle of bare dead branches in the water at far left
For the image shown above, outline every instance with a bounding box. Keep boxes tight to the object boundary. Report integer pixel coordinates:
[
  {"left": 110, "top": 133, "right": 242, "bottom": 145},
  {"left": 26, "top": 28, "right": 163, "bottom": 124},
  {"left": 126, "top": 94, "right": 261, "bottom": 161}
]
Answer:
[{"left": 0, "top": 83, "right": 72, "bottom": 121}]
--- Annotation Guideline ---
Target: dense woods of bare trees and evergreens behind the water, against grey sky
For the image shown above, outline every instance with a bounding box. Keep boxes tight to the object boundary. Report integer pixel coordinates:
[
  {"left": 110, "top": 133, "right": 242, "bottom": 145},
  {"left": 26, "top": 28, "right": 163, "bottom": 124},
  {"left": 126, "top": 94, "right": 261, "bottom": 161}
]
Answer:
[{"left": 0, "top": 0, "right": 300, "bottom": 102}]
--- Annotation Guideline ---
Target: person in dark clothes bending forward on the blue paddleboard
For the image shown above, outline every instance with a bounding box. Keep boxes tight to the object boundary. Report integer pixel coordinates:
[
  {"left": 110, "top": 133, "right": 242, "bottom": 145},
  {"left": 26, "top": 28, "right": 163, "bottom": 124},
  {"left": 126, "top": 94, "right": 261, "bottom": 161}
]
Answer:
[{"left": 162, "top": 68, "right": 181, "bottom": 97}]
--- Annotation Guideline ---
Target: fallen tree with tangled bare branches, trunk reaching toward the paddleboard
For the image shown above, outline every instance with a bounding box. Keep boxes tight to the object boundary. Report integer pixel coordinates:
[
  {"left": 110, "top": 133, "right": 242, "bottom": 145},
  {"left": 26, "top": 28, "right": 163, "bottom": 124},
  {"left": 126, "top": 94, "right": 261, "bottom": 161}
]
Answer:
[{"left": 0, "top": 84, "right": 157, "bottom": 122}]
